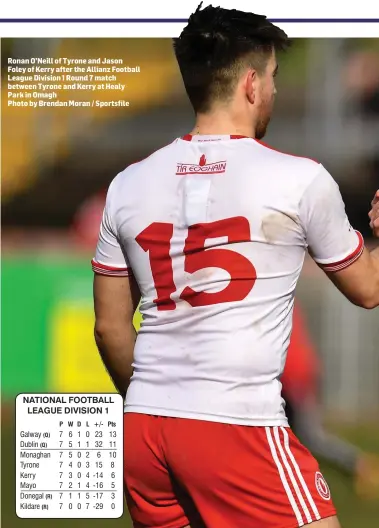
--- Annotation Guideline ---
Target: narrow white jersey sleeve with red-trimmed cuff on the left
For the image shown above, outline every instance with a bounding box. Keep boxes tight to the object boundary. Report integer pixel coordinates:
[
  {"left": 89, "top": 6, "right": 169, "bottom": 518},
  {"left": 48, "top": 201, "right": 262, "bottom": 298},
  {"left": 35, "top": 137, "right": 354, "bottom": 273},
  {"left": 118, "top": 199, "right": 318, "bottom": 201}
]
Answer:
[{"left": 91, "top": 177, "right": 132, "bottom": 277}]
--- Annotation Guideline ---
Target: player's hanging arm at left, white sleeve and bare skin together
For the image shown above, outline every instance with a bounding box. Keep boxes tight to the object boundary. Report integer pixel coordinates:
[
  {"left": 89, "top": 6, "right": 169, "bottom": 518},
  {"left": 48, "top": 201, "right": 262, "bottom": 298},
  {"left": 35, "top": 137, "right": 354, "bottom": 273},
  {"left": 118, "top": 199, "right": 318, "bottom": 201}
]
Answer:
[{"left": 92, "top": 175, "right": 140, "bottom": 396}]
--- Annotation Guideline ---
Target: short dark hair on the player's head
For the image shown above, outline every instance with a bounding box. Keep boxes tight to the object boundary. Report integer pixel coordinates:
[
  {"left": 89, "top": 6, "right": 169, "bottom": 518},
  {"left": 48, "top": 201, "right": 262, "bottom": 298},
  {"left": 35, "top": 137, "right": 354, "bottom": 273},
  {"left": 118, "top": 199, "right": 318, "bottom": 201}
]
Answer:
[{"left": 173, "top": 2, "right": 290, "bottom": 113}]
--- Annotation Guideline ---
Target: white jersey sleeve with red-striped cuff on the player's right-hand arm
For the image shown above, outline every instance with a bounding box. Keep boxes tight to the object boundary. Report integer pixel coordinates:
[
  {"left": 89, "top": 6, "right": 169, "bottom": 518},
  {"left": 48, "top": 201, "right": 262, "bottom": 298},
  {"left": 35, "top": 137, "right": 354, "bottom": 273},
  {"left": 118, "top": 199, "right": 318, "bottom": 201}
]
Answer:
[{"left": 300, "top": 165, "right": 364, "bottom": 272}]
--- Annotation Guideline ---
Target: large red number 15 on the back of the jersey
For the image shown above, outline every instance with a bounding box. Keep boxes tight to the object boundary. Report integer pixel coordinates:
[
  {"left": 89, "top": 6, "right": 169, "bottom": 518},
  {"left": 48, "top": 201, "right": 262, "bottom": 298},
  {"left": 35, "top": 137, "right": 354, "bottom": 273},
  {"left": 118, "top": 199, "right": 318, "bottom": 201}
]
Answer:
[{"left": 136, "top": 216, "right": 257, "bottom": 310}]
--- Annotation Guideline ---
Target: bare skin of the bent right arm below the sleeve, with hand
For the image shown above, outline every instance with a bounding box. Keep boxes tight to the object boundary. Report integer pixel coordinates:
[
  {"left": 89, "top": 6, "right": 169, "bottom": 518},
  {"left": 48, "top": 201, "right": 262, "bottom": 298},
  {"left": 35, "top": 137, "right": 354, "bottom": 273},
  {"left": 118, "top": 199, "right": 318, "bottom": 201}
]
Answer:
[{"left": 327, "top": 191, "right": 379, "bottom": 309}]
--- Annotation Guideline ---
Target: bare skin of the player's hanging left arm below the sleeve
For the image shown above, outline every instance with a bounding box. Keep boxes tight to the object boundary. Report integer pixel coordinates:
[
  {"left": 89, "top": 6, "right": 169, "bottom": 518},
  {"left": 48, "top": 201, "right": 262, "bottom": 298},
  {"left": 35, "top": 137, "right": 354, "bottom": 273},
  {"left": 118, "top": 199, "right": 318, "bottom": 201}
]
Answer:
[{"left": 94, "top": 274, "right": 140, "bottom": 397}]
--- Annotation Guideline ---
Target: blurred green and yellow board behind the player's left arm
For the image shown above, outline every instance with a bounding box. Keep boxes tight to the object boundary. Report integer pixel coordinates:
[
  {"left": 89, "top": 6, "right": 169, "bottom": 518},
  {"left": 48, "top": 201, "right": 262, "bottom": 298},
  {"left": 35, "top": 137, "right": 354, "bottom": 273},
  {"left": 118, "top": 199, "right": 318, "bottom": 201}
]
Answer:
[{"left": 2, "top": 256, "right": 119, "bottom": 398}]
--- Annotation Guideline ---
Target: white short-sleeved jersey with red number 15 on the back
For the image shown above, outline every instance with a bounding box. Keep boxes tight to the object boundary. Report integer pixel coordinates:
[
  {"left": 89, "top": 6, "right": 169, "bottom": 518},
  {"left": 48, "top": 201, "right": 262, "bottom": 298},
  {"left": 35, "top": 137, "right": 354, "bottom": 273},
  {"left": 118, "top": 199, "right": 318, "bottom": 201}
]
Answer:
[{"left": 92, "top": 136, "right": 363, "bottom": 426}]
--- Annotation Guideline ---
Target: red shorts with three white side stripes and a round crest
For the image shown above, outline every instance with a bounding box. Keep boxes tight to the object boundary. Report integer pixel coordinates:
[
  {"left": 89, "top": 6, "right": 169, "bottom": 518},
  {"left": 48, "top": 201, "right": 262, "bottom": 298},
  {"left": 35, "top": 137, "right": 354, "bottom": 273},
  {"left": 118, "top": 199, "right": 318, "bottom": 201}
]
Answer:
[{"left": 124, "top": 413, "right": 336, "bottom": 528}]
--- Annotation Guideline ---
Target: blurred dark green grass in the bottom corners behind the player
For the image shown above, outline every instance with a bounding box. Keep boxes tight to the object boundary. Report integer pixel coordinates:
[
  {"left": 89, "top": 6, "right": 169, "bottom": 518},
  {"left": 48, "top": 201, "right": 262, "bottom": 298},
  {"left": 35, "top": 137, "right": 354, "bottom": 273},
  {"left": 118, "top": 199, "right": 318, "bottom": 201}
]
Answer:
[{"left": 1, "top": 413, "right": 379, "bottom": 528}]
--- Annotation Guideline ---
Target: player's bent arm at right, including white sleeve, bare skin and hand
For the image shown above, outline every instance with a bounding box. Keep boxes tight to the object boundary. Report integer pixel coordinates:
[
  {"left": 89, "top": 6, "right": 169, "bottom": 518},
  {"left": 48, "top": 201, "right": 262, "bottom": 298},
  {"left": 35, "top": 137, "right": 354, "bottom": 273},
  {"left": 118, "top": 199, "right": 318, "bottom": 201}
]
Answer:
[{"left": 301, "top": 166, "right": 379, "bottom": 309}]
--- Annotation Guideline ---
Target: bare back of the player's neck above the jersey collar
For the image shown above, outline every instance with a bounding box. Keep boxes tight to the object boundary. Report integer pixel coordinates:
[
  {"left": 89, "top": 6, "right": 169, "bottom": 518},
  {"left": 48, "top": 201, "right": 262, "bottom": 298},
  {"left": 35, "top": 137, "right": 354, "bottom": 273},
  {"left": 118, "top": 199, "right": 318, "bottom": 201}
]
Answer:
[{"left": 190, "top": 112, "right": 255, "bottom": 138}]
